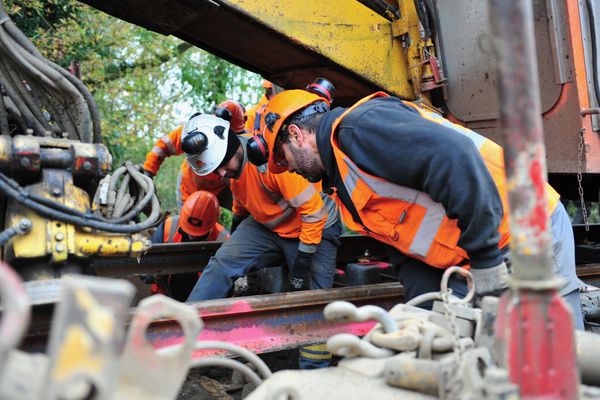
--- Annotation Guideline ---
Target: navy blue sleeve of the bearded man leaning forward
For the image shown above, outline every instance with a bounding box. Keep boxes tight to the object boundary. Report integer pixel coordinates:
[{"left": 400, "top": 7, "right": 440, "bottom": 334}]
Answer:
[{"left": 338, "top": 97, "right": 503, "bottom": 268}]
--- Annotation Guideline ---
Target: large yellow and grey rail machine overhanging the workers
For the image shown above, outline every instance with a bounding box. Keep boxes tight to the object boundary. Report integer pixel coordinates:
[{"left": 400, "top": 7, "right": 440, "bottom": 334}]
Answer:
[{"left": 82, "top": 0, "right": 600, "bottom": 195}]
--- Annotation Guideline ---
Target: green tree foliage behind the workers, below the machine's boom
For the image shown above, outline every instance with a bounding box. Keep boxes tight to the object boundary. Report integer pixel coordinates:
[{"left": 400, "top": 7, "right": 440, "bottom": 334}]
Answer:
[{"left": 4, "top": 0, "right": 261, "bottom": 216}]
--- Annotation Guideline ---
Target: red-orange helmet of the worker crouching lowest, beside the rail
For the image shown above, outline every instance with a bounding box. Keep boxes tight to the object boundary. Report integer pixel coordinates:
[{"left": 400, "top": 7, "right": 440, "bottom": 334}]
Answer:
[{"left": 179, "top": 190, "right": 221, "bottom": 236}]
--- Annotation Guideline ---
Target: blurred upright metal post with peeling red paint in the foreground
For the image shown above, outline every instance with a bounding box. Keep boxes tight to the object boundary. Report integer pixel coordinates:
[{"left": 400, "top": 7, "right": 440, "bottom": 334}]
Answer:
[{"left": 490, "top": 0, "right": 579, "bottom": 399}]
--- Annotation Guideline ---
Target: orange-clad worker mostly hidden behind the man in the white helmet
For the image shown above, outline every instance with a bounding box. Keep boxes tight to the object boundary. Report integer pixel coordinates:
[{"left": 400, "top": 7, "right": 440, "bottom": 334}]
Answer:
[{"left": 144, "top": 100, "right": 246, "bottom": 210}]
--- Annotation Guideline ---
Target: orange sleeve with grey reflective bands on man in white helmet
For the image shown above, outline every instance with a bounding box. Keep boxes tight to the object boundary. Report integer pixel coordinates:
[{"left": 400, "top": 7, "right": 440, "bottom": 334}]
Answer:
[{"left": 269, "top": 172, "right": 329, "bottom": 253}]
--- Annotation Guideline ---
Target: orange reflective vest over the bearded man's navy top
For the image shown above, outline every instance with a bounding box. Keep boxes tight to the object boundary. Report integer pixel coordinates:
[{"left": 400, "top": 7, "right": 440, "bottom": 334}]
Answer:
[{"left": 331, "top": 92, "right": 560, "bottom": 268}]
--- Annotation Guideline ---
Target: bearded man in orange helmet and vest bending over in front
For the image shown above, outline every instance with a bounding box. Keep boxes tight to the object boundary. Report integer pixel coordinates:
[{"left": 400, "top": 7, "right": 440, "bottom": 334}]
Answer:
[{"left": 256, "top": 85, "right": 585, "bottom": 329}]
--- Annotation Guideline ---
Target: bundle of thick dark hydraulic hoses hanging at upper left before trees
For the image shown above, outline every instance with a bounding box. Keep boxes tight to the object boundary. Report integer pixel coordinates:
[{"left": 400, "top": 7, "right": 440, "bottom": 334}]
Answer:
[{"left": 0, "top": 2, "right": 102, "bottom": 143}]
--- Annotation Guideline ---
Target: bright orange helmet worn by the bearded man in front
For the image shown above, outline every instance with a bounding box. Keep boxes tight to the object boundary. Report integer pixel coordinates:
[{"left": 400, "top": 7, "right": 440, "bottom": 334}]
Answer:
[{"left": 261, "top": 89, "right": 330, "bottom": 174}]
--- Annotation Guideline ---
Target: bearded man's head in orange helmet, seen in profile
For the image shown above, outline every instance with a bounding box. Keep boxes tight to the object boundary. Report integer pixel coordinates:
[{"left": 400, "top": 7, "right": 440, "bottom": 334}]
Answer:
[{"left": 262, "top": 90, "right": 330, "bottom": 182}]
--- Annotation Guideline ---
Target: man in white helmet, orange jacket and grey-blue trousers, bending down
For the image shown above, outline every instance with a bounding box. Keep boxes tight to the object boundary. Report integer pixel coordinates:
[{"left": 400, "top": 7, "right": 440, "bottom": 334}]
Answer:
[{"left": 182, "top": 115, "right": 341, "bottom": 368}]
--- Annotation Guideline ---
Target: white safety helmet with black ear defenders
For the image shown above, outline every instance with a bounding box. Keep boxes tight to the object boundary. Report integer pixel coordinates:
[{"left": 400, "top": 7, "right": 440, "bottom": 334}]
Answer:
[{"left": 181, "top": 114, "right": 229, "bottom": 176}]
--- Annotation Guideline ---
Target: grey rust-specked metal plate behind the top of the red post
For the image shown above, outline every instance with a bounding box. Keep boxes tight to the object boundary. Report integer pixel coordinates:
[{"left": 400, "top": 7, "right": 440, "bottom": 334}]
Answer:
[{"left": 436, "top": 0, "right": 562, "bottom": 122}]
